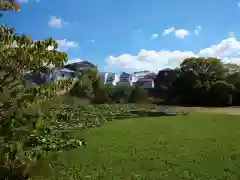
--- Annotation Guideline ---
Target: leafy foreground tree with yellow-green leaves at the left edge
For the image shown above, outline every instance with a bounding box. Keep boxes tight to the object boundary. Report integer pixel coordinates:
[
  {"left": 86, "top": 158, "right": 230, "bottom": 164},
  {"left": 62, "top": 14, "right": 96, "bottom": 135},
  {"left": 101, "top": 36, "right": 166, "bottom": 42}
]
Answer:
[{"left": 0, "top": 25, "right": 85, "bottom": 179}]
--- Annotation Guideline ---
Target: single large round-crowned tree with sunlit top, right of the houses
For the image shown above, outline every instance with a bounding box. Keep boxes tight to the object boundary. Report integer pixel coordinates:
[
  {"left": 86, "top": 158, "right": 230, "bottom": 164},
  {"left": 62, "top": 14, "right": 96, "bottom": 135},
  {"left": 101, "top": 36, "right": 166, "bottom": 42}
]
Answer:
[{"left": 171, "top": 58, "right": 227, "bottom": 105}]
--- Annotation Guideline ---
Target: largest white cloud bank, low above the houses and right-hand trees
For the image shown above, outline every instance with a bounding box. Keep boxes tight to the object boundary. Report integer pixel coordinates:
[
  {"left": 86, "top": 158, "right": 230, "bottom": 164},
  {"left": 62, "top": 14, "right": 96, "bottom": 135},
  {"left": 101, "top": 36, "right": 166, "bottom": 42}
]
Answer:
[{"left": 106, "top": 38, "right": 240, "bottom": 72}]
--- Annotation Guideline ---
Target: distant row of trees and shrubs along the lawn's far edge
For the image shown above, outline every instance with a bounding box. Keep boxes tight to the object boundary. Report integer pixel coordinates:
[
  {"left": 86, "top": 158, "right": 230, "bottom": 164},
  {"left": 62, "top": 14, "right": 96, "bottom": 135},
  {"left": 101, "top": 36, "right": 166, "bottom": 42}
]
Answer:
[{"left": 75, "top": 58, "right": 240, "bottom": 106}]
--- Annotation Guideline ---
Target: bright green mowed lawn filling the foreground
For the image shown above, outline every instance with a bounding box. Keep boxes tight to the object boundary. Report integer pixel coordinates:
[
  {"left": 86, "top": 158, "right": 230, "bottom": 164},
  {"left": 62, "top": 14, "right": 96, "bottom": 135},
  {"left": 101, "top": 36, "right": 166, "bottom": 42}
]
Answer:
[{"left": 34, "top": 113, "right": 240, "bottom": 180}]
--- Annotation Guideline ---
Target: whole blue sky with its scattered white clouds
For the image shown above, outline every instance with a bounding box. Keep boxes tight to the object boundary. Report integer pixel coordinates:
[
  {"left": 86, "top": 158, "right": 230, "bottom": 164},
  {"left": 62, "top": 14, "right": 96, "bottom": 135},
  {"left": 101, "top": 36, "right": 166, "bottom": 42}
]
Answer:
[{"left": 1, "top": 0, "right": 240, "bottom": 72}]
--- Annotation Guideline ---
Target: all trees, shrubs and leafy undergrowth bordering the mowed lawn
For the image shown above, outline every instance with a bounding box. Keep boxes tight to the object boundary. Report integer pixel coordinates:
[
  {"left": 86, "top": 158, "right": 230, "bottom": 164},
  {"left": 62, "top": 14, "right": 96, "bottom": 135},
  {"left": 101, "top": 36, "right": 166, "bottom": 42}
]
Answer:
[{"left": 0, "top": 2, "right": 240, "bottom": 179}]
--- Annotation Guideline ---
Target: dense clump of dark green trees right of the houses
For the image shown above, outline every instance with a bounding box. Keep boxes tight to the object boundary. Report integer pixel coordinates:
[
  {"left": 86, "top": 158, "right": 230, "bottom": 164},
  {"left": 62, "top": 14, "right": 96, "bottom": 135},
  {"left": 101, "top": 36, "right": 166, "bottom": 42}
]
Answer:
[{"left": 155, "top": 58, "right": 240, "bottom": 106}]
